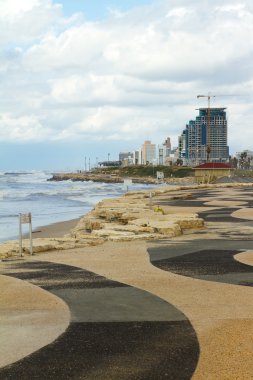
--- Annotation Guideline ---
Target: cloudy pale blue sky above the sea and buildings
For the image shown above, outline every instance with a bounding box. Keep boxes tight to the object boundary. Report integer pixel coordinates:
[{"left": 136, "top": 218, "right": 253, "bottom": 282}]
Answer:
[{"left": 0, "top": 0, "right": 253, "bottom": 170}]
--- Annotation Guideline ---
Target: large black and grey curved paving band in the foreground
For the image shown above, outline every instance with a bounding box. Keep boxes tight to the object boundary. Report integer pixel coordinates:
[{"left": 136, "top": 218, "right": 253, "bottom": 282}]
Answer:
[{"left": 0, "top": 261, "right": 199, "bottom": 380}]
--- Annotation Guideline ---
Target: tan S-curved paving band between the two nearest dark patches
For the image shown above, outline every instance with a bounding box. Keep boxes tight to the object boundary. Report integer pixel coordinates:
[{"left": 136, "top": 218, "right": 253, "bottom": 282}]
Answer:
[{"left": 18, "top": 240, "right": 253, "bottom": 380}]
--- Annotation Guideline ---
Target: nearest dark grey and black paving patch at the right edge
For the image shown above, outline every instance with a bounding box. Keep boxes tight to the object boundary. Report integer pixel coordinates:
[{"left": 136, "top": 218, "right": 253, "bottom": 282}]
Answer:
[{"left": 148, "top": 240, "right": 253, "bottom": 286}]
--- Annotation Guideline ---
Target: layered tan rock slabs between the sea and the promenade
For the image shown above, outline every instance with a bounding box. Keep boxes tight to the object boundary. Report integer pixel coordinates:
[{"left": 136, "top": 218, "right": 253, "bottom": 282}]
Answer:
[{"left": 0, "top": 186, "right": 204, "bottom": 258}]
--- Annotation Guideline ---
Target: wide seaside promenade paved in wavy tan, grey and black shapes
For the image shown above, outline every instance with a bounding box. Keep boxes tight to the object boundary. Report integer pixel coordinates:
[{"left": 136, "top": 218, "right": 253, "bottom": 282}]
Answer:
[{"left": 0, "top": 185, "right": 253, "bottom": 380}]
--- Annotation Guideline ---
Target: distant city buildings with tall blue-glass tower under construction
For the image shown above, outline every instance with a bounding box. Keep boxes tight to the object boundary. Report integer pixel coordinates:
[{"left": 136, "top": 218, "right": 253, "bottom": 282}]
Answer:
[{"left": 101, "top": 107, "right": 249, "bottom": 169}]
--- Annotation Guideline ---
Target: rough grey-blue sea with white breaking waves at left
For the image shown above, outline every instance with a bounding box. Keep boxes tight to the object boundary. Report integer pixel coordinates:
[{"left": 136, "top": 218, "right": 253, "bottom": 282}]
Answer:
[{"left": 0, "top": 171, "right": 158, "bottom": 242}]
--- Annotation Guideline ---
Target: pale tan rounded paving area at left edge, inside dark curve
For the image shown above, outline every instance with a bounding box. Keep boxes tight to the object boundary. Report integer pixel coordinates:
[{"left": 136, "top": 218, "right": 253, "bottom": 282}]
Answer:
[{"left": 0, "top": 270, "right": 70, "bottom": 368}]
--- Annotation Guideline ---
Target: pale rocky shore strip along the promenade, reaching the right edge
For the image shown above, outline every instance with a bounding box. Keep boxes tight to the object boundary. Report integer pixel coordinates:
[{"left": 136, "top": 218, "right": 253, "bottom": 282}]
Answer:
[{"left": 0, "top": 183, "right": 252, "bottom": 259}]
